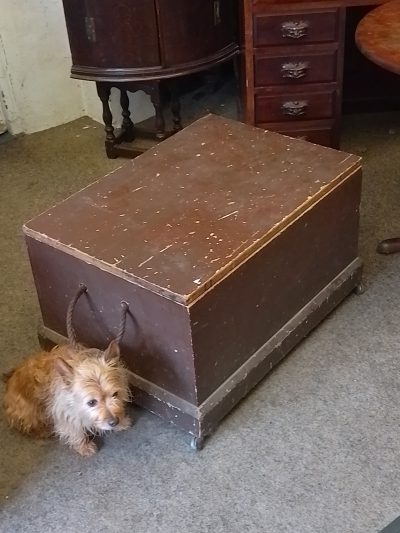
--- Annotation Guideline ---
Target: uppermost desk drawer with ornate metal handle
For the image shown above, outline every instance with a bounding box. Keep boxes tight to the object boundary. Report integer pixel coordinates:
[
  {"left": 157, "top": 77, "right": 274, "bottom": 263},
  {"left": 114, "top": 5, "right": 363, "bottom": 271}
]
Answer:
[{"left": 254, "top": 9, "right": 339, "bottom": 47}]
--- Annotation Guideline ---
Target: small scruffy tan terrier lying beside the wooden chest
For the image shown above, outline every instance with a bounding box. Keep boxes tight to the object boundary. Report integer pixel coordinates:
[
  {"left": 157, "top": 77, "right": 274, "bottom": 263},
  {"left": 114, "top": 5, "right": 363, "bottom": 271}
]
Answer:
[{"left": 4, "top": 341, "right": 130, "bottom": 456}]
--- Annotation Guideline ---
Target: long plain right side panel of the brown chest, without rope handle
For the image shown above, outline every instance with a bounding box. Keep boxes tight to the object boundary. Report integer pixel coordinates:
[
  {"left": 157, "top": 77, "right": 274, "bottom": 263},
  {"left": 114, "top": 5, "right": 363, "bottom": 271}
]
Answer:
[{"left": 190, "top": 173, "right": 361, "bottom": 403}]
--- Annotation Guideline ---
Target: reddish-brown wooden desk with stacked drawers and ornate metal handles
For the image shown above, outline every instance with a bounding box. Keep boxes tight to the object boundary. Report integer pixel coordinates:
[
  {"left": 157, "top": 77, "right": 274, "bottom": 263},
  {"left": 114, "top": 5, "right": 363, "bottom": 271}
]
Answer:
[{"left": 242, "top": 0, "right": 390, "bottom": 147}]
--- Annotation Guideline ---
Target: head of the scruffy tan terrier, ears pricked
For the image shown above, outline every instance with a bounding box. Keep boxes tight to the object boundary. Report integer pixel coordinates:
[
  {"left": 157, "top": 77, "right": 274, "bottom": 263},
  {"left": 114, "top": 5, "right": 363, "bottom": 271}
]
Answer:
[{"left": 55, "top": 341, "right": 129, "bottom": 433}]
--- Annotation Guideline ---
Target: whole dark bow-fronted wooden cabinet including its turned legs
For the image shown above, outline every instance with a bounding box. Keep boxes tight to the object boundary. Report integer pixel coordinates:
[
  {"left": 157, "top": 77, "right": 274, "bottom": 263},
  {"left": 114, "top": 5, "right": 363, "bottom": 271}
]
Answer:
[{"left": 63, "top": 0, "right": 239, "bottom": 157}]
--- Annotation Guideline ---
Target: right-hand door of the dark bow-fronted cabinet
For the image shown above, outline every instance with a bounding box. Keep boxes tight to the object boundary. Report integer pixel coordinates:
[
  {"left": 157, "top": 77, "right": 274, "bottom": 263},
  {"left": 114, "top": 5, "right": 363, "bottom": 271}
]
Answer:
[{"left": 156, "top": 0, "right": 238, "bottom": 67}]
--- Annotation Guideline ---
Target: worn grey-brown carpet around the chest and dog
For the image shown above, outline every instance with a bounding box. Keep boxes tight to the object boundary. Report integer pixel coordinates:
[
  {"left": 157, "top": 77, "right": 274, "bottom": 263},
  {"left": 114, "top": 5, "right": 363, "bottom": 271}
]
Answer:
[{"left": 0, "top": 102, "right": 400, "bottom": 533}]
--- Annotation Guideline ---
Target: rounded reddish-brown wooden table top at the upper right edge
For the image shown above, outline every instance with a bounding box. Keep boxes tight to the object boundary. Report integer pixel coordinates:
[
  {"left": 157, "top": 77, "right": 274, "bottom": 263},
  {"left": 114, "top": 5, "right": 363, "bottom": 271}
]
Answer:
[{"left": 355, "top": 0, "right": 400, "bottom": 74}]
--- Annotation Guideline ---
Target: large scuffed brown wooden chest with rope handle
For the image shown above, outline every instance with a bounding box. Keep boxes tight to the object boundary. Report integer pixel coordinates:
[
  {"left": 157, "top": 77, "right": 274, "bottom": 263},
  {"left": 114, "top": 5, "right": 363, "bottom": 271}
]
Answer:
[{"left": 24, "top": 116, "right": 361, "bottom": 446}]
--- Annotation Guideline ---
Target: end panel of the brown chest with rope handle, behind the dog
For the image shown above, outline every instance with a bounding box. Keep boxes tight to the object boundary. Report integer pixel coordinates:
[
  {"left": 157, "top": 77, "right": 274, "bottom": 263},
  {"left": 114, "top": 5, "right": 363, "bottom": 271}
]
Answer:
[{"left": 27, "top": 237, "right": 196, "bottom": 403}]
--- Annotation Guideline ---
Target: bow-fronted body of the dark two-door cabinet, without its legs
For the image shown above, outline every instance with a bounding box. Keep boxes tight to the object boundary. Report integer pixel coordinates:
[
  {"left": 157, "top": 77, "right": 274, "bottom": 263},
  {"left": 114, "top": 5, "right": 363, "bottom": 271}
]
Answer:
[{"left": 63, "top": 0, "right": 238, "bottom": 81}]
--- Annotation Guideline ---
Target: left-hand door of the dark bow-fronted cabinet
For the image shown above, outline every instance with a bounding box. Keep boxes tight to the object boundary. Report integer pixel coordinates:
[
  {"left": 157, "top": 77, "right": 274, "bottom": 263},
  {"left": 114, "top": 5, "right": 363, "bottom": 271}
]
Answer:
[{"left": 63, "top": 0, "right": 160, "bottom": 69}]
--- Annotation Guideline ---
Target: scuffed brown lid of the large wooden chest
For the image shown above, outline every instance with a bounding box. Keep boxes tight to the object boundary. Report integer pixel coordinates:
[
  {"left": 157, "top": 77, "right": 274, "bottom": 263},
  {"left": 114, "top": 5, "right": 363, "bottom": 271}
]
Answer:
[{"left": 24, "top": 115, "right": 360, "bottom": 304}]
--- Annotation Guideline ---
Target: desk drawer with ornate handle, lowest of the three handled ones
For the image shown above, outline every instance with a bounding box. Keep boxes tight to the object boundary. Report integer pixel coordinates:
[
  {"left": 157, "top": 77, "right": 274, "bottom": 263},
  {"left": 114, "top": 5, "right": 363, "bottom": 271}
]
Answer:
[{"left": 255, "top": 90, "right": 336, "bottom": 123}]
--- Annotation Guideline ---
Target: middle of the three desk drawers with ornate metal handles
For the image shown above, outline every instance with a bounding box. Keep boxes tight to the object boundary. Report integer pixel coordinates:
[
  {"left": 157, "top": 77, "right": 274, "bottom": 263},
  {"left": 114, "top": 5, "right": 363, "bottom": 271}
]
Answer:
[{"left": 254, "top": 51, "right": 337, "bottom": 87}]
